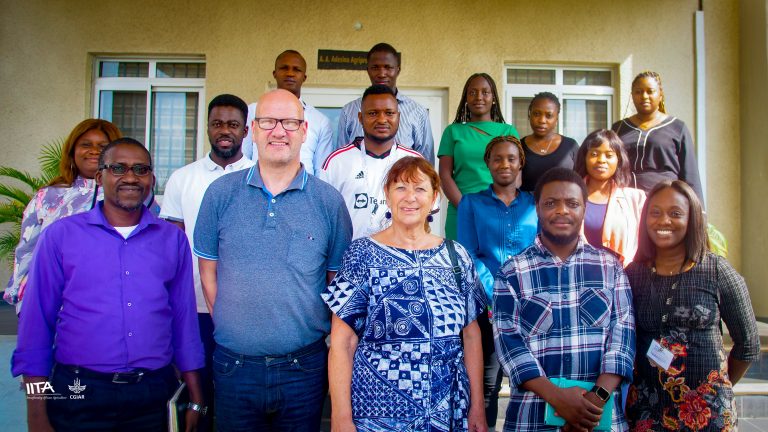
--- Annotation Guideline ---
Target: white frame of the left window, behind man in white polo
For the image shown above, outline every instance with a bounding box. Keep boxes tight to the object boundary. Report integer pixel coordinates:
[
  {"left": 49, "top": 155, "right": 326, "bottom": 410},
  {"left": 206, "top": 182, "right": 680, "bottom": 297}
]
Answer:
[{"left": 91, "top": 56, "right": 207, "bottom": 179}]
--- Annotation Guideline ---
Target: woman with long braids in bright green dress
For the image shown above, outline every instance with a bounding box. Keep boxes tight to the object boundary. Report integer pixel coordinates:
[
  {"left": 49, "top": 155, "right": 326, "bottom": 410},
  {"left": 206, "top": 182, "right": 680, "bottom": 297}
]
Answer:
[{"left": 437, "top": 73, "right": 520, "bottom": 240}]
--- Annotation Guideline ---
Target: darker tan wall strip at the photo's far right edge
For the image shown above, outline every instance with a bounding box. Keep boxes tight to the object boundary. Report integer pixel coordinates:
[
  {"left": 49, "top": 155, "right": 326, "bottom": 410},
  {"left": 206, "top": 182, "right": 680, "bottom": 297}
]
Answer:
[{"left": 739, "top": 0, "right": 768, "bottom": 317}]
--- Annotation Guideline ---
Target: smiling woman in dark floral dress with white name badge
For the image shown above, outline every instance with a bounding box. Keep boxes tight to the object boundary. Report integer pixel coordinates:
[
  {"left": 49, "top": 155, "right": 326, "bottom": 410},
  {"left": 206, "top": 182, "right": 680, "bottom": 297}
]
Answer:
[{"left": 626, "top": 180, "right": 760, "bottom": 432}]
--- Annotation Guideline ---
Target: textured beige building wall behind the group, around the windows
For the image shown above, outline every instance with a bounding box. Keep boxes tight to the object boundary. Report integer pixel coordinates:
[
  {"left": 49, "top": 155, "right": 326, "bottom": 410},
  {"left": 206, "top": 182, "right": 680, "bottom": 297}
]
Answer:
[{"left": 0, "top": 0, "right": 756, "bottom": 315}]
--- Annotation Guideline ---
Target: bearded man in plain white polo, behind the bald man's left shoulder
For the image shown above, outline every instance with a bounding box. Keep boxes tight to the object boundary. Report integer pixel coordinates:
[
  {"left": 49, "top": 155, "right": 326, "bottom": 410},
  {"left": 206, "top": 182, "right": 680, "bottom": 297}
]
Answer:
[{"left": 160, "top": 94, "right": 254, "bottom": 431}]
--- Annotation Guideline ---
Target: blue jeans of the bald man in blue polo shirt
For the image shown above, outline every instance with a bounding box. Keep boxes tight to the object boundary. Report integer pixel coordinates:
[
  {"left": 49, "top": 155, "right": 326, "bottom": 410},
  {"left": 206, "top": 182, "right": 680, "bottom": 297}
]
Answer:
[{"left": 213, "top": 339, "right": 328, "bottom": 432}]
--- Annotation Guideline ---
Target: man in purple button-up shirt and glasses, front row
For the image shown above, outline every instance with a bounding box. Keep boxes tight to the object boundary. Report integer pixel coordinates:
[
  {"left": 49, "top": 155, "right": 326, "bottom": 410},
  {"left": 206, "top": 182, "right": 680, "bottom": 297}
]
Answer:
[{"left": 12, "top": 138, "right": 205, "bottom": 431}]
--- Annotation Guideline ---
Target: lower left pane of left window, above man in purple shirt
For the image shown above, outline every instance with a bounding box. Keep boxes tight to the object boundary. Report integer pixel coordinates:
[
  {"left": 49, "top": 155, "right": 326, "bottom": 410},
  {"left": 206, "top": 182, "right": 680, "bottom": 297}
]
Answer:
[{"left": 99, "top": 90, "right": 147, "bottom": 144}]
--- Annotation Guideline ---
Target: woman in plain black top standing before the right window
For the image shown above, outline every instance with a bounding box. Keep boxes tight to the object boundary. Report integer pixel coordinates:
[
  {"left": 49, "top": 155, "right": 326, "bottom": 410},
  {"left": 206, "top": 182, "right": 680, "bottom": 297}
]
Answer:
[{"left": 520, "top": 92, "right": 579, "bottom": 192}]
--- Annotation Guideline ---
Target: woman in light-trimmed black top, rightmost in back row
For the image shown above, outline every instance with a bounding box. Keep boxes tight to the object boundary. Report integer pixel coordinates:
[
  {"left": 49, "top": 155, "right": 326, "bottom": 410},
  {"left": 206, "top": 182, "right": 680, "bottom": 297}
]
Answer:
[{"left": 612, "top": 71, "right": 704, "bottom": 202}]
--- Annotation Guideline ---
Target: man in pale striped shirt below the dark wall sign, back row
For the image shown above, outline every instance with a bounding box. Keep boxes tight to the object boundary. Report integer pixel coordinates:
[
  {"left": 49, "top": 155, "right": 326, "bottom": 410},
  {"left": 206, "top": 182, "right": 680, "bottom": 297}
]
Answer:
[{"left": 336, "top": 42, "right": 435, "bottom": 165}]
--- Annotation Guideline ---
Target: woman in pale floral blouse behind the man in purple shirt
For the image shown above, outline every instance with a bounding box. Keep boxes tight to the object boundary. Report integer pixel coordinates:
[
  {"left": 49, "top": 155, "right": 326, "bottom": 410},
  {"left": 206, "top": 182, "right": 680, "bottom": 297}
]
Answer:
[{"left": 3, "top": 119, "right": 122, "bottom": 313}]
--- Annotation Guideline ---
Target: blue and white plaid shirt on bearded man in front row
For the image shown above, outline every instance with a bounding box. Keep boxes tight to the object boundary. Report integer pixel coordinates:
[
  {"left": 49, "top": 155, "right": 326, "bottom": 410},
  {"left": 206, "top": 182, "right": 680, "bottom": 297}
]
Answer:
[{"left": 493, "top": 236, "right": 635, "bottom": 431}]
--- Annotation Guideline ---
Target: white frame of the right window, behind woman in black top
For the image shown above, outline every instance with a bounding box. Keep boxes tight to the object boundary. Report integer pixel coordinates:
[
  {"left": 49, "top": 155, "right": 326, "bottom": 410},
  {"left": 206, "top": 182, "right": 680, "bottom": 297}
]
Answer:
[{"left": 502, "top": 63, "right": 617, "bottom": 141}]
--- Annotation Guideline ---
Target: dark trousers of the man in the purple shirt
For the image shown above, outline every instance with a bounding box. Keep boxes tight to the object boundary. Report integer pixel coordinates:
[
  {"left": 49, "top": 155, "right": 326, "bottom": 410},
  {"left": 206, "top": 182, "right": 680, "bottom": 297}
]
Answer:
[{"left": 46, "top": 365, "right": 179, "bottom": 432}]
